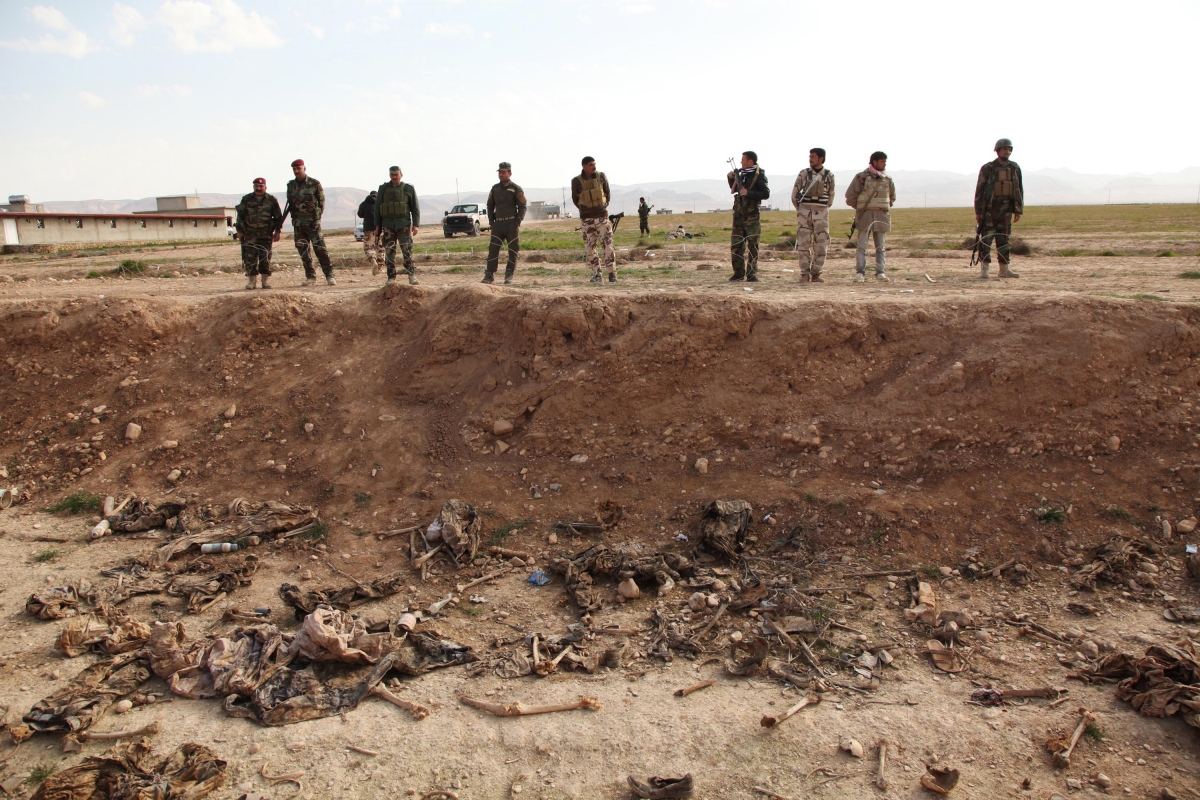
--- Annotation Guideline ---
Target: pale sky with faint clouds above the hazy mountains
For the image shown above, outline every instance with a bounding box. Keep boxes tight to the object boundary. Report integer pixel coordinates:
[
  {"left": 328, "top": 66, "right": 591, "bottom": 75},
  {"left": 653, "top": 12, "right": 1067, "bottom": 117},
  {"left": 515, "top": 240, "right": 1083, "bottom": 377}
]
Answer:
[{"left": 0, "top": 0, "right": 1200, "bottom": 200}]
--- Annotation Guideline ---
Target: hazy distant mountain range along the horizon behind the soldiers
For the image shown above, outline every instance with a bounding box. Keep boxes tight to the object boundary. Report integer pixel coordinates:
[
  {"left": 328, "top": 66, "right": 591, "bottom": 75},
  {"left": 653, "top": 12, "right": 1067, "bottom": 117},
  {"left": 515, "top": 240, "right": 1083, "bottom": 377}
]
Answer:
[{"left": 34, "top": 167, "right": 1200, "bottom": 228}]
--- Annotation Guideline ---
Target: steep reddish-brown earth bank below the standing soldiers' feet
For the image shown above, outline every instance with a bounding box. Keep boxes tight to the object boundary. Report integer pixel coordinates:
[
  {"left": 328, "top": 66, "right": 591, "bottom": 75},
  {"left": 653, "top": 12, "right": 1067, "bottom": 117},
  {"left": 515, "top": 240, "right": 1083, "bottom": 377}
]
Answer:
[{"left": 0, "top": 287, "right": 1200, "bottom": 566}]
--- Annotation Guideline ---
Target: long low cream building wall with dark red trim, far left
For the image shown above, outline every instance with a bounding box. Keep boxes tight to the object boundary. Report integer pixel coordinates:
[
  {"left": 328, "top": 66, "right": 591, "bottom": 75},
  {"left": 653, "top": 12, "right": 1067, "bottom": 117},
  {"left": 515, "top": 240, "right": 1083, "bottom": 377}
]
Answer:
[{"left": 0, "top": 213, "right": 229, "bottom": 247}]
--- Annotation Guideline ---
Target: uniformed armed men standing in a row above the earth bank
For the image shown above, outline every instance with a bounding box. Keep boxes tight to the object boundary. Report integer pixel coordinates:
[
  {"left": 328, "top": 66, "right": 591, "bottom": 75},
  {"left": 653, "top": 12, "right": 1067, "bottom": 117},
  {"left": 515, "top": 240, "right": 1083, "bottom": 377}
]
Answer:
[{"left": 236, "top": 139, "right": 1025, "bottom": 289}]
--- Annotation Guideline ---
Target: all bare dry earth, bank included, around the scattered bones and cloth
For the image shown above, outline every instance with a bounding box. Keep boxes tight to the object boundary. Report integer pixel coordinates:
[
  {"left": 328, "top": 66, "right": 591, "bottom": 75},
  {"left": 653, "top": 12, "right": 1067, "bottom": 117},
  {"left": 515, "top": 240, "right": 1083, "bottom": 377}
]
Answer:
[{"left": 0, "top": 208, "right": 1200, "bottom": 800}]
